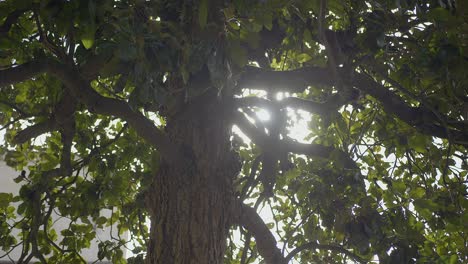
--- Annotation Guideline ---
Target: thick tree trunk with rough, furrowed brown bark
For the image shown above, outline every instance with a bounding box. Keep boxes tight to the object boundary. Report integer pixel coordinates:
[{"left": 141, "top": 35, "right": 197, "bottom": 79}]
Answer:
[{"left": 146, "top": 95, "right": 239, "bottom": 264}]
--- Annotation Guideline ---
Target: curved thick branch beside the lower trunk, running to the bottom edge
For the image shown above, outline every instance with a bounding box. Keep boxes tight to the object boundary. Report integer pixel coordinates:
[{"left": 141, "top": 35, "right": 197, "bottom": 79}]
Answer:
[{"left": 233, "top": 202, "right": 287, "bottom": 264}]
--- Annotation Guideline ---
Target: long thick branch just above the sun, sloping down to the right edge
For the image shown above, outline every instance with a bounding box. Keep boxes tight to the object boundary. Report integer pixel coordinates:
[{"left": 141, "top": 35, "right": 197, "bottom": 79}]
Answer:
[{"left": 239, "top": 67, "right": 468, "bottom": 145}]
